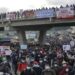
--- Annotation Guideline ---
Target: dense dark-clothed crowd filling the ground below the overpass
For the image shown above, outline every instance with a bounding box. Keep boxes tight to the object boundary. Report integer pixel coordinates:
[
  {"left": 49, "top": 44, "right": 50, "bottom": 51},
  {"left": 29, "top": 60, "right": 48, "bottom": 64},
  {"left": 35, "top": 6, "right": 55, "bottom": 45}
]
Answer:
[{"left": 0, "top": 29, "right": 75, "bottom": 75}]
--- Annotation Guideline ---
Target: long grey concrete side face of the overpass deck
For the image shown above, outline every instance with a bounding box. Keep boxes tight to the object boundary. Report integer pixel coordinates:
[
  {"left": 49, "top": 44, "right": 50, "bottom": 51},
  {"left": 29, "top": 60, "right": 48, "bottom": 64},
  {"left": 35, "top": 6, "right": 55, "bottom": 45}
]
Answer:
[{"left": 0, "top": 18, "right": 75, "bottom": 27}]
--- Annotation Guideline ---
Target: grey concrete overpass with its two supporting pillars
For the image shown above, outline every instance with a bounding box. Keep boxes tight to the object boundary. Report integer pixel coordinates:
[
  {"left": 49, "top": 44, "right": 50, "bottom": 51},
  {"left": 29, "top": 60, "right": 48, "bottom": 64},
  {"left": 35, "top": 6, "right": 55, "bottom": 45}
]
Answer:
[{"left": 0, "top": 18, "right": 75, "bottom": 42}]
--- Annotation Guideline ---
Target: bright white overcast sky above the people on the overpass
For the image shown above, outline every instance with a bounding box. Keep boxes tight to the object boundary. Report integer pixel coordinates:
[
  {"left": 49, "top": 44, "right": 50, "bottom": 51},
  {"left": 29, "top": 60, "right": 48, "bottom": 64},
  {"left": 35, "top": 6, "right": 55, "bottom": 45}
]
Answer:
[{"left": 0, "top": 0, "right": 75, "bottom": 11}]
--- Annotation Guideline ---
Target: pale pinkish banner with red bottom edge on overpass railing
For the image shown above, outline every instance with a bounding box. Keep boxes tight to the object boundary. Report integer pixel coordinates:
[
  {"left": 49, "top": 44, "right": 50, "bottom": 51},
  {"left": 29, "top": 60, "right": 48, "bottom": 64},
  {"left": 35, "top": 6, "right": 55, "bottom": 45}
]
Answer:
[{"left": 56, "top": 7, "right": 74, "bottom": 19}]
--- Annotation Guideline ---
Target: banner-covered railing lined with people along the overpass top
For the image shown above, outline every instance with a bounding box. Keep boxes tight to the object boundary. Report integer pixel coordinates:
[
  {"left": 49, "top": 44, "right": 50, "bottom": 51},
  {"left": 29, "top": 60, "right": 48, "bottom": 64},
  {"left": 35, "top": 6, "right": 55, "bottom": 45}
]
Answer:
[{"left": 0, "top": 5, "right": 75, "bottom": 22}]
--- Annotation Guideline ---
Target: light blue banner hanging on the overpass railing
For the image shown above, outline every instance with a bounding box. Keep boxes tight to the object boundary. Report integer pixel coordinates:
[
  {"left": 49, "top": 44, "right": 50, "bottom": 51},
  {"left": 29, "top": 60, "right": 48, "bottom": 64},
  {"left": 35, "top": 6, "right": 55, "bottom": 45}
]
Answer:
[{"left": 35, "top": 9, "right": 55, "bottom": 18}]
